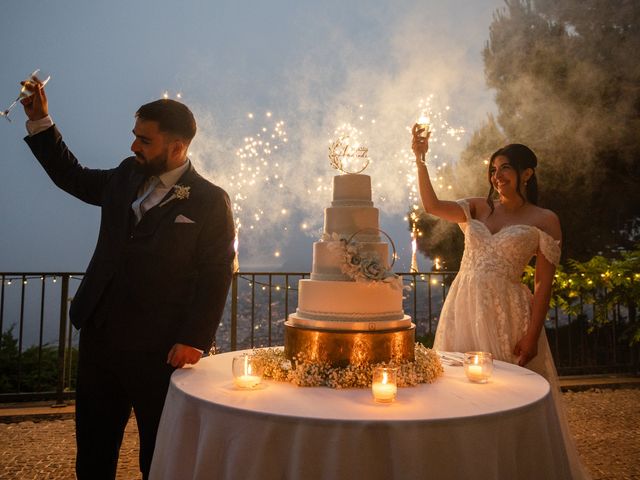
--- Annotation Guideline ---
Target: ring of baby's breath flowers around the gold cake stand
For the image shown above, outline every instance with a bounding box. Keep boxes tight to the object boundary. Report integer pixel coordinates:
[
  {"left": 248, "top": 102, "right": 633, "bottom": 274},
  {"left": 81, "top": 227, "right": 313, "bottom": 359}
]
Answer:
[{"left": 251, "top": 343, "right": 444, "bottom": 389}]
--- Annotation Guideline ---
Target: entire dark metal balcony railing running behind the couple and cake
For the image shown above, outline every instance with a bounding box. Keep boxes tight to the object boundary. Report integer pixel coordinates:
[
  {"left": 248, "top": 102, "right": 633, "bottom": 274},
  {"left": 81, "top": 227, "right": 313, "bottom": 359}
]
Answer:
[{"left": 0, "top": 271, "right": 640, "bottom": 404}]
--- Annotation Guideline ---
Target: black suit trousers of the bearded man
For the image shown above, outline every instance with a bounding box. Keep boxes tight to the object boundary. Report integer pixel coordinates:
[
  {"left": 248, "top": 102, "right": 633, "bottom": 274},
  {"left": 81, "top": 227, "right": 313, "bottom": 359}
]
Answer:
[{"left": 76, "top": 326, "right": 174, "bottom": 480}]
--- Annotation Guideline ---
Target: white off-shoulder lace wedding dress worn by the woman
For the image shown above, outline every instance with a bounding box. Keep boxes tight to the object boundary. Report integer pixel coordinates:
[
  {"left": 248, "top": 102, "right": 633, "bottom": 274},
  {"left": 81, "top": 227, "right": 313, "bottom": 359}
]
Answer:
[{"left": 433, "top": 200, "right": 589, "bottom": 478}]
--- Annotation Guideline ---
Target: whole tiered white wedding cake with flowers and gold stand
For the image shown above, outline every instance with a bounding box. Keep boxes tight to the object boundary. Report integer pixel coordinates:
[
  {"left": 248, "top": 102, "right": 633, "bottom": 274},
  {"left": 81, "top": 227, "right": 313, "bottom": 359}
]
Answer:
[{"left": 285, "top": 174, "right": 415, "bottom": 366}]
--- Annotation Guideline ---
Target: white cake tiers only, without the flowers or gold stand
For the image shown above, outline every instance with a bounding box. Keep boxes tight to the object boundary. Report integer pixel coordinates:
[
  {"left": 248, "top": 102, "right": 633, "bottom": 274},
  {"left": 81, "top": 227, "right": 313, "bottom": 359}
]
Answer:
[{"left": 288, "top": 174, "right": 411, "bottom": 331}]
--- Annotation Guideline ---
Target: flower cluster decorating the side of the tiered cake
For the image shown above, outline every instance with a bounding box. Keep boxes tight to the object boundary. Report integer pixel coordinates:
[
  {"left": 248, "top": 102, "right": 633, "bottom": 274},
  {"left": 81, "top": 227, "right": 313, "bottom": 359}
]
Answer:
[{"left": 322, "top": 233, "right": 402, "bottom": 289}]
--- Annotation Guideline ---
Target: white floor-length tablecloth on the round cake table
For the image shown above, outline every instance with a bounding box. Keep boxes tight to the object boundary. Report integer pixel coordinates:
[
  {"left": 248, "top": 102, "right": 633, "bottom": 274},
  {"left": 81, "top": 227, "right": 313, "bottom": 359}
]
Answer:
[{"left": 151, "top": 352, "right": 570, "bottom": 480}]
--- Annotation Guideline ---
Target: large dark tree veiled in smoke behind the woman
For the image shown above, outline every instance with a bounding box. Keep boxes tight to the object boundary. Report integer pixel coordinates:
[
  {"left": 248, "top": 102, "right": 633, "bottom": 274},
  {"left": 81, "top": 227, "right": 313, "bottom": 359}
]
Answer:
[{"left": 484, "top": 0, "right": 640, "bottom": 259}]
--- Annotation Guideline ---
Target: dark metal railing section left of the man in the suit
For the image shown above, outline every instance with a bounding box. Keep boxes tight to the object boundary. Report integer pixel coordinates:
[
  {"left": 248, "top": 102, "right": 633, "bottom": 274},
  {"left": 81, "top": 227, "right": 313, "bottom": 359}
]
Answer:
[{"left": 0, "top": 272, "right": 84, "bottom": 405}]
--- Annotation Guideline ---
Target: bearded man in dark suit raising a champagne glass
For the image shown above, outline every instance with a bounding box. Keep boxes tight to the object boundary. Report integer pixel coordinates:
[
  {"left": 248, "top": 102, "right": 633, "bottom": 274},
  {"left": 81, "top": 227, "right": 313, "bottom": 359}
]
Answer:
[{"left": 22, "top": 80, "right": 234, "bottom": 480}]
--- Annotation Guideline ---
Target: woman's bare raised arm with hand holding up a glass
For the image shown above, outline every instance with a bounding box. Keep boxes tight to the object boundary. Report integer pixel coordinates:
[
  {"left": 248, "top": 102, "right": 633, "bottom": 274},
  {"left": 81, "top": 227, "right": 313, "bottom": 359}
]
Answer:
[{"left": 411, "top": 124, "right": 467, "bottom": 223}]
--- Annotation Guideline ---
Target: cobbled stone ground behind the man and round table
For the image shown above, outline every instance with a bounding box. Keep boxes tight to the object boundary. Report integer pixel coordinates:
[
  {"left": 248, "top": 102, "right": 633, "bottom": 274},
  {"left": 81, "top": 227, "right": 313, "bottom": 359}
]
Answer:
[{"left": 0, "top": 388, "right": 640, "bottom": 480}]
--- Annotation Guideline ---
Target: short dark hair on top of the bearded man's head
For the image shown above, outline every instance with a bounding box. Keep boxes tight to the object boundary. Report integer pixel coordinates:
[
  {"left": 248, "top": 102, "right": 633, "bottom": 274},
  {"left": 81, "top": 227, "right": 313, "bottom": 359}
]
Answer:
[{"left": 136, "top": 98, "right": 196, "bottom": 142}]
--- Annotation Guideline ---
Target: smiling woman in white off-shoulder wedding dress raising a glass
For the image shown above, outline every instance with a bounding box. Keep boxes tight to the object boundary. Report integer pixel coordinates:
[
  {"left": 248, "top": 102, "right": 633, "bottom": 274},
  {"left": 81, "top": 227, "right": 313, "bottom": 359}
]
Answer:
[{"left": 412, "top": 125, "right": 588, "bottom": 478}]
